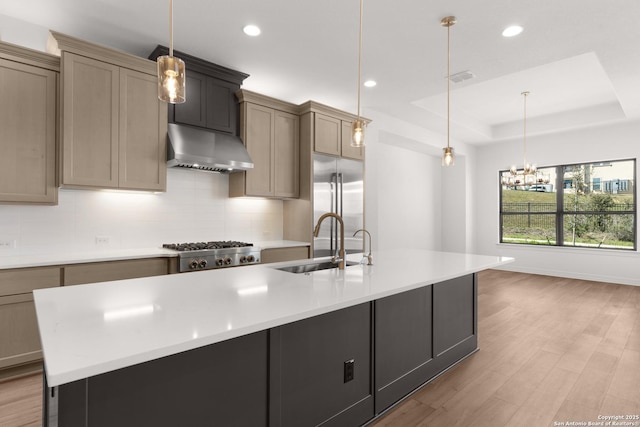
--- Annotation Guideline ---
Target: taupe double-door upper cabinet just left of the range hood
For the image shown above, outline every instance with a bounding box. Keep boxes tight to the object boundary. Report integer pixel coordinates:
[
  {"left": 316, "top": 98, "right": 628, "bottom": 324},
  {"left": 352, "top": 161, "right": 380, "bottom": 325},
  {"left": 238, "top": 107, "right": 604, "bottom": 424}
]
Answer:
[{"left": 50, "top": 32, "right": 167, "bottom": 191}]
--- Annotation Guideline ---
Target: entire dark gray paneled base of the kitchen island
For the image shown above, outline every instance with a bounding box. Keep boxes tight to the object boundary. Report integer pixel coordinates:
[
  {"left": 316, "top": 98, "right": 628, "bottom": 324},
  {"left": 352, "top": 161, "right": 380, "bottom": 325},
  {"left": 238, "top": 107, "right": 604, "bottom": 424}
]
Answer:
[{"left": 44, "top": 274, "right": 477, "bottom": 427}]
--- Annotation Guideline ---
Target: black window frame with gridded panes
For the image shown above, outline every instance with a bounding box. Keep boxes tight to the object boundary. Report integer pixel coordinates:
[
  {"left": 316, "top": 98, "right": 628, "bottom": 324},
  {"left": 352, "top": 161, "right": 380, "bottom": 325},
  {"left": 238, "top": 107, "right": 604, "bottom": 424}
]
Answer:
[{"left": 498, "top": 158, "right": 638, "bottom": 251}]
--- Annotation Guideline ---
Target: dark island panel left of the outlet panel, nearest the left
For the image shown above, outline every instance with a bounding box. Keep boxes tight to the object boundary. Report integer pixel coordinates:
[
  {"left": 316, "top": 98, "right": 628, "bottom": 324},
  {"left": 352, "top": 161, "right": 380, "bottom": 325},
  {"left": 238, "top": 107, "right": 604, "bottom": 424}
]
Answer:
[{"left": 51, "top": 331, "right": 268, "bottom": 427}]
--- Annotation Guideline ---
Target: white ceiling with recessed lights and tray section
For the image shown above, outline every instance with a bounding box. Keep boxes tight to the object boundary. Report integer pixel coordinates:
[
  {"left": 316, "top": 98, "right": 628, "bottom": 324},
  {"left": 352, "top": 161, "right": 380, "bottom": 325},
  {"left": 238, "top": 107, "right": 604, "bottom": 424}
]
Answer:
[{"left": 0, "top": 0, "right": 640, "bottom": 144}]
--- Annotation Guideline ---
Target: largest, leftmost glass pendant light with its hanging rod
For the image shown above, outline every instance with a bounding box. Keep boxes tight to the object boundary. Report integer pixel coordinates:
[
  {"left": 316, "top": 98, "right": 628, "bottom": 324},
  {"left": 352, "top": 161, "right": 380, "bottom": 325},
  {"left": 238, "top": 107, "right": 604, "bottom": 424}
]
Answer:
[{"left": 158, "top": 0, "right": 186, "bottom": 104}]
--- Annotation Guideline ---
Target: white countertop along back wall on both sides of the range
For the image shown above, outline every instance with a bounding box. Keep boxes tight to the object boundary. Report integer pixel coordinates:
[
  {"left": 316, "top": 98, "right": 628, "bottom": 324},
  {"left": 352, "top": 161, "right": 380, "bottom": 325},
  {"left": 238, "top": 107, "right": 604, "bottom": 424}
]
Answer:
[{"left": 0, "top": 240, "right": 310, "bottom": 270}]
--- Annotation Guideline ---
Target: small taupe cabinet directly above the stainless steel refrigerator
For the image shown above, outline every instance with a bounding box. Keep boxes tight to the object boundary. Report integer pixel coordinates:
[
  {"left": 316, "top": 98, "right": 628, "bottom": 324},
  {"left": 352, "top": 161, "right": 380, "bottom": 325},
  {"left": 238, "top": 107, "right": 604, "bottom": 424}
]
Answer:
[{"left": 300, "top": 101, "right": 368, "bottom": 160}]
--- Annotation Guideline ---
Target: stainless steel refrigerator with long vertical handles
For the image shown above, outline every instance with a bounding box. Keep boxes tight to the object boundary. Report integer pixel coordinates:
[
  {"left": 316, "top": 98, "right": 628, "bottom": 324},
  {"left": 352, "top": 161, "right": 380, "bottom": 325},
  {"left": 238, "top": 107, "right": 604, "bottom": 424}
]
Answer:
[{"left": 313, "top": 154, "right": 364, "bottom": 258}]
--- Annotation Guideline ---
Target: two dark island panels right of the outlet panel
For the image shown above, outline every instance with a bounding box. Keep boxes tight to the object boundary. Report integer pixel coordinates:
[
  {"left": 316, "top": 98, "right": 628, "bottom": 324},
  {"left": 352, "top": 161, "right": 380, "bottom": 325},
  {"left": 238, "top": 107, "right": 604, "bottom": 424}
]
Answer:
[{"left": 374, "top": 275, "right": 477, "bottom": 414}]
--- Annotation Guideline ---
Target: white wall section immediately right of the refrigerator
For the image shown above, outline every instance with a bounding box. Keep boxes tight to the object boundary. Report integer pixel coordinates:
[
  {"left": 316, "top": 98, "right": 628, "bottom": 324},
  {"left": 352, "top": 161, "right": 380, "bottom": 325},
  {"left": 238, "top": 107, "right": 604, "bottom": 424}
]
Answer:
[{"left": 364, "top": 110, "right": 452, "bottom": 254}]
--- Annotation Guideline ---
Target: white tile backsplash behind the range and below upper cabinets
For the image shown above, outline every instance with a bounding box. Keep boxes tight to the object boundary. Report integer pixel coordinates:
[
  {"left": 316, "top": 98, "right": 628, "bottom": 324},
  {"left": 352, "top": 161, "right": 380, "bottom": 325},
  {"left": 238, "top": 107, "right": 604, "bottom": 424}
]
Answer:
[{"left": 0, "top": 169, "right": 282, "bottom": 256}]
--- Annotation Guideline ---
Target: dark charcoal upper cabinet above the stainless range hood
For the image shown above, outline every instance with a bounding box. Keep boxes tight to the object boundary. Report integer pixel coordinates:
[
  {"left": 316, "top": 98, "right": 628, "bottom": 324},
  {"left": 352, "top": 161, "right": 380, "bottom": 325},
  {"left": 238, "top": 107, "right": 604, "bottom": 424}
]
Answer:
[{"left": 149, "top": 46, "right": 249, "bottom": 135}]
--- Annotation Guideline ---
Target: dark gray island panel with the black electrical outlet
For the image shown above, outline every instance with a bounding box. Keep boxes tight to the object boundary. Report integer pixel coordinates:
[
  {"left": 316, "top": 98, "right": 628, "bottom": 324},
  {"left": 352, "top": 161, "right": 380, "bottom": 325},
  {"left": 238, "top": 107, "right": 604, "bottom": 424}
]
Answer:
[{"left": 269, "top": 303, "right": 373, "bottom": 427}]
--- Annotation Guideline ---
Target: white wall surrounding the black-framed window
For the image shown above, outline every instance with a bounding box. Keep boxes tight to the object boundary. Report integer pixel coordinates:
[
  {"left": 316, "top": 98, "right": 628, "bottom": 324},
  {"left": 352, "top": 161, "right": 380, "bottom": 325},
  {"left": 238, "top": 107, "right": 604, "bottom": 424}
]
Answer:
[{"left": 474, "top": 121, "right": 640, "bottom": 285}]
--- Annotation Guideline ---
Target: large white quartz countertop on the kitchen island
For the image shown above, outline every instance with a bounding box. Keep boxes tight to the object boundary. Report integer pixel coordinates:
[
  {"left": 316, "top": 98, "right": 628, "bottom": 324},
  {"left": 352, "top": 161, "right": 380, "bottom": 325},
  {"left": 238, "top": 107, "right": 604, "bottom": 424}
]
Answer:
[{"left": 33, "top": 250, "right": 513, "bottom": 386}]
